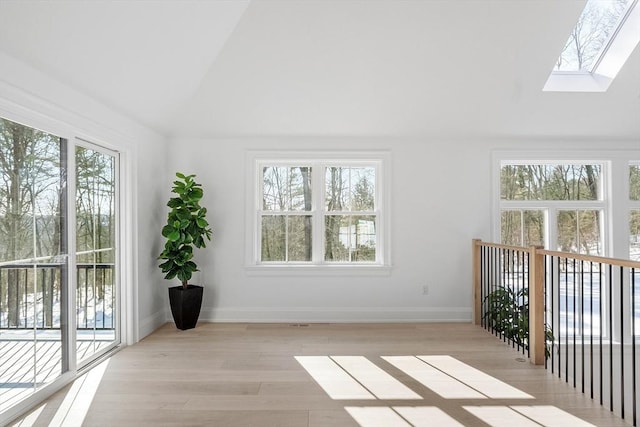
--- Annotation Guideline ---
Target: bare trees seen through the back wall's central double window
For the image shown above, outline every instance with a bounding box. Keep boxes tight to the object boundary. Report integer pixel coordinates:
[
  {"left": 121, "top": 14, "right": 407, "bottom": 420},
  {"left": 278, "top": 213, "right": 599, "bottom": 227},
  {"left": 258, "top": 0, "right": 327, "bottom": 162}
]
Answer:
[{"left": 260, "top": 165, "right": 376, "bottom": 262}]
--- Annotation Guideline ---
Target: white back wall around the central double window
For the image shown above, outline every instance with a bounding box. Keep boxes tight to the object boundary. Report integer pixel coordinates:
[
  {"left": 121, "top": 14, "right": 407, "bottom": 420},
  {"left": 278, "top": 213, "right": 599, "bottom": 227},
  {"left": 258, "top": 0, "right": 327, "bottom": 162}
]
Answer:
[{"left": 167, "top": 137, "right": 640, "bottom": 322}]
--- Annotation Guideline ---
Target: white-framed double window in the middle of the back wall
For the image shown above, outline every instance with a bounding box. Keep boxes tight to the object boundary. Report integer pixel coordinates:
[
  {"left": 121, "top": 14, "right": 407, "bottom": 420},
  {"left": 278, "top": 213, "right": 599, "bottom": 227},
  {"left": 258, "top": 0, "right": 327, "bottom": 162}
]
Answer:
[{"left": 247, "top": 152, "right": 389, "bottom": 267}]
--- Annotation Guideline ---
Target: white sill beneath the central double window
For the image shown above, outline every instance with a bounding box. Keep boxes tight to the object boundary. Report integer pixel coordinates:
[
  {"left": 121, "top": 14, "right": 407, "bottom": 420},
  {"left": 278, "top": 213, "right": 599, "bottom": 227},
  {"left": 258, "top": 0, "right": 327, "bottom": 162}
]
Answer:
[{"left": 245, "top": 265, "right": 392, "bottom": 277}]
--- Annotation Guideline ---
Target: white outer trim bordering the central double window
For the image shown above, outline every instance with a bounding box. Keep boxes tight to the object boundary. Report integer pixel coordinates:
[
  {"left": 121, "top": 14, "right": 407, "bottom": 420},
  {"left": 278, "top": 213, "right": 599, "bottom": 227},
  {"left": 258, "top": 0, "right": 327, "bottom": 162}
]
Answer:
[{"left": 245, "top": 150, "right": 391, "bottom": 276}]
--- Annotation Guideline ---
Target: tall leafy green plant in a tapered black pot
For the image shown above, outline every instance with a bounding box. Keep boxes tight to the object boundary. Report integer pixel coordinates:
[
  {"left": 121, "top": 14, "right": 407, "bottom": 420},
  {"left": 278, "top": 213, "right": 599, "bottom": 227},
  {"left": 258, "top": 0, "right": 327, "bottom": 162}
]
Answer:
[{"left": 158, "top": 172, "right": 211, "bottom": 330}]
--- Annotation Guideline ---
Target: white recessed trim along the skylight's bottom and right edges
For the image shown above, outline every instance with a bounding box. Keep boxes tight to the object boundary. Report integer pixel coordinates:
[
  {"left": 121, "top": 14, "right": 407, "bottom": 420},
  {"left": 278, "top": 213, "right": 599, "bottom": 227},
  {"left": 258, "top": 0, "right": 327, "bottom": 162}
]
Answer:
[{"left": 542, "top": 1, "right": 640, "bottom": 92}]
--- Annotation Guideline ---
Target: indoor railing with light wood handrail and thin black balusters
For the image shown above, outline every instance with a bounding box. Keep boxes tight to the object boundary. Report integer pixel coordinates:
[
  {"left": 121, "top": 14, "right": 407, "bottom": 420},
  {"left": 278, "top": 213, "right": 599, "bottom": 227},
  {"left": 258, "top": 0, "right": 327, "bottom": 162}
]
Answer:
[{"left": 473, "top": 240, "right": 640, "bottom": 426}]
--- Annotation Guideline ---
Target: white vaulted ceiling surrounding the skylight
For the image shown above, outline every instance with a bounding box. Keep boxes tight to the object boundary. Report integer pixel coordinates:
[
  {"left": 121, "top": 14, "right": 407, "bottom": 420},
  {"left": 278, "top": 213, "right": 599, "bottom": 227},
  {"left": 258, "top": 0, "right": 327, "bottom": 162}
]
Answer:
[{"left": 0, "top": 0, "right": 640, "bottom": 138}]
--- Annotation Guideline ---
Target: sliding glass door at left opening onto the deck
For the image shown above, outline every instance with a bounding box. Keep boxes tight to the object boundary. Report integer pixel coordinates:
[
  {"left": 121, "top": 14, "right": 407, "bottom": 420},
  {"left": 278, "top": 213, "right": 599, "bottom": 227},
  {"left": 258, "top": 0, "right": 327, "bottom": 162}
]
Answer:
[{"left": 0, "top": 118, "right": 120, "bottom": 424}]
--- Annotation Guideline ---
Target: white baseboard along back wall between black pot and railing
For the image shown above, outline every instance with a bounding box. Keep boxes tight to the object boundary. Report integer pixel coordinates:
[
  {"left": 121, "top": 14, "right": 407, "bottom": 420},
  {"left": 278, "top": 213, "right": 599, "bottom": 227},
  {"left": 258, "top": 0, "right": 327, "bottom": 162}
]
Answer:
[{"left": 200, "top": 307, "right": 472, "bottom": 323}]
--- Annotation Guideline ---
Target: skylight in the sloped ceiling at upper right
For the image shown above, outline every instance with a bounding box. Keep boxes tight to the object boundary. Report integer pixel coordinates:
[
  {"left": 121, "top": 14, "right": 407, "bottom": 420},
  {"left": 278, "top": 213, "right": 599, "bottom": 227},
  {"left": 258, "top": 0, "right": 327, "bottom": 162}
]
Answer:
[{"left": 544, "top": 0, "right": 640, "bottom": 92}]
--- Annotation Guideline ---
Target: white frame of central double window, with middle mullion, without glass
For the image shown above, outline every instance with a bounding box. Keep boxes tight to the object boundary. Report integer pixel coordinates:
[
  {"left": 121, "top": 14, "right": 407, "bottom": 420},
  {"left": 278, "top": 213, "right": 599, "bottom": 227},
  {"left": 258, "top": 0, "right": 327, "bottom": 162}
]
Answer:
[{"left": 245, "top": 150, "right": 391, "bottom": 275}]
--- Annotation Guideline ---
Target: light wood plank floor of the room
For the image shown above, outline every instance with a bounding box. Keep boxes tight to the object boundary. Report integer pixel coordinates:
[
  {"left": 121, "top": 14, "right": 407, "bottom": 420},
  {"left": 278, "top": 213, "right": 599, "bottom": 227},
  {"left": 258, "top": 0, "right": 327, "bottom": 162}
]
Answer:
[{"left": 7, "top": 323, "right": 628, "bottom": 427}]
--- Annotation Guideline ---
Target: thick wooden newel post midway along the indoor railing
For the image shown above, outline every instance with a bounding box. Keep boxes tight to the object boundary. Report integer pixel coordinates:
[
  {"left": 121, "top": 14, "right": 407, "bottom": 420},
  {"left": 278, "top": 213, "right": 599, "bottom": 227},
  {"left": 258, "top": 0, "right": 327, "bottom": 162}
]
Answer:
[{"left": 529, "top": 246, "right": 546, "bottom": 365}]
